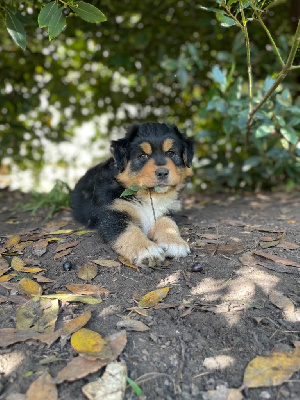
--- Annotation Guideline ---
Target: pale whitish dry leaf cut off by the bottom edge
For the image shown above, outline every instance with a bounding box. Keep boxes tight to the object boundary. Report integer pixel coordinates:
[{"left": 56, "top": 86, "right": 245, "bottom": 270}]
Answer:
[{"left": 82, "top": 362, "right": 127, "bottom": 400}]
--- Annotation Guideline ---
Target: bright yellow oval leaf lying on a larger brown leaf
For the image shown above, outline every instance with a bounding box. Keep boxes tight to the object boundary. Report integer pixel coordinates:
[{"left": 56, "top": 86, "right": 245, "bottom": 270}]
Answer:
[{"left": 71, "top": 328, "right": 111, "bottom": 359}]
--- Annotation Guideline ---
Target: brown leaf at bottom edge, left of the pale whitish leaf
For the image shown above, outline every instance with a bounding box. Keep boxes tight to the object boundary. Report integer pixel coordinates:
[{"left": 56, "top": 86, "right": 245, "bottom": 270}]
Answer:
[{"left": 26, "top": 371, "right": 58, "bottom": 400}]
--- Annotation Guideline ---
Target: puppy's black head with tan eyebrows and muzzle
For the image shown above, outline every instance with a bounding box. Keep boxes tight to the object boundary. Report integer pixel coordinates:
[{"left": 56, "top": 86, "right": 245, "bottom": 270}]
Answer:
[{"left": 111, "top": 122, "right": 194, "bottom": 193}]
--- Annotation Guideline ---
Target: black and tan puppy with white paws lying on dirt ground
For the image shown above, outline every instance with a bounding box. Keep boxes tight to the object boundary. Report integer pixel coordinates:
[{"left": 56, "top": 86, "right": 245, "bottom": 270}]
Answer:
[{"left": 72, "top": 122, "right": 194, "bottom": 266}]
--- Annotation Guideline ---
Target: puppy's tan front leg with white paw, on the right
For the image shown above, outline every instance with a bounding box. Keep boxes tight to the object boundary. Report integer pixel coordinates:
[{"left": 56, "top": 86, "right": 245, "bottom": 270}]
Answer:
[{"left": 148, "top": 217, "right": 190, "bottom": 258}]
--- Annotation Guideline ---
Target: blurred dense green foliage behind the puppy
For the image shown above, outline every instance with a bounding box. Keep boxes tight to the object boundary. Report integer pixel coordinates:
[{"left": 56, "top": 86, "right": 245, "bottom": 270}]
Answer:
[{"left": 0, "top": 0, "right": 300, "bottom": 189}]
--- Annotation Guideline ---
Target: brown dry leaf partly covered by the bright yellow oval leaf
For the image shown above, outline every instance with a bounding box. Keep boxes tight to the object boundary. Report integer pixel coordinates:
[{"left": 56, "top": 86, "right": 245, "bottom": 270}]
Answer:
[{"left": 53, "top": 331, "right": 127, "bottom": 383}]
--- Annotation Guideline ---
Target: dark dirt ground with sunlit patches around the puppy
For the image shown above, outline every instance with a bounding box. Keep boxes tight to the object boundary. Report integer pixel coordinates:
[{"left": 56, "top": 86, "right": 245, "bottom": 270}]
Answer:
[{"left": 0, "top": 191, "right": 300, "bottom": 400}]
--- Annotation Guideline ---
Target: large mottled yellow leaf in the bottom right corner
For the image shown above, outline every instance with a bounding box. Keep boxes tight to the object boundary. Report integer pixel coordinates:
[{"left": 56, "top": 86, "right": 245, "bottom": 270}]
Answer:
[{"left": 244, "top": 348, "right": 300, "bottom": 388}]
